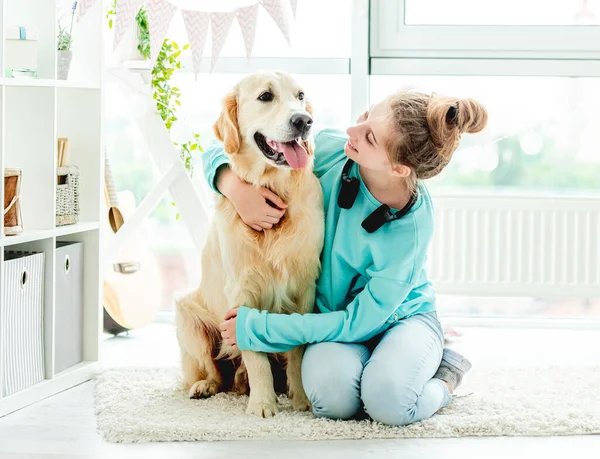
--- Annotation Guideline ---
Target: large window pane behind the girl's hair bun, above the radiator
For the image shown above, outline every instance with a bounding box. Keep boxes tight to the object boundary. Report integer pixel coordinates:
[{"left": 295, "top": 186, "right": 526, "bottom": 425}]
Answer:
[{"left": 371, "top": 76, "right": 600, "bottom": 194}]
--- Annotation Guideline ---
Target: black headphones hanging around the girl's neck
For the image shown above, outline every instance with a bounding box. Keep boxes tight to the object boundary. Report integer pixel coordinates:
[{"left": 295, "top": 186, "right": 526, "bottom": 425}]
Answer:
[{"left": 338, "top": 159, "right": 418, "bottom": 233}]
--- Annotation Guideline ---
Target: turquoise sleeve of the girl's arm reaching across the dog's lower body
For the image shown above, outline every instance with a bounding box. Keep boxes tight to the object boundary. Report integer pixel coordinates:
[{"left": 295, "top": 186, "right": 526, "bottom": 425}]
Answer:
[{"left": 235, "top": 216, "right": 430, "bottom": 352}]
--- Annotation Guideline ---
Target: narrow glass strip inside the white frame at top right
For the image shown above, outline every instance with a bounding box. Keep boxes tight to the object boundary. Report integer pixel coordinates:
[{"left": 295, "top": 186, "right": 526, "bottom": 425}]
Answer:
[{"left": 405, "top": 0, "right": 600, "bottom": 25}]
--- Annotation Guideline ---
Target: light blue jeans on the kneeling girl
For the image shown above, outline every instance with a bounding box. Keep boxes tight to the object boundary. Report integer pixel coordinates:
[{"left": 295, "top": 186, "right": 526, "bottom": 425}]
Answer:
[{"left": 302, "top": 312, "right": 452, "bottom": 425}]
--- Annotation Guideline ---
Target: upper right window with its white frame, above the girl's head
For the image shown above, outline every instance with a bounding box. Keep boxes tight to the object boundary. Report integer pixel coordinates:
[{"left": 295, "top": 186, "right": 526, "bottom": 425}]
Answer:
[{"left": 371, "top": 0, "right": 600, "bottom": 59}]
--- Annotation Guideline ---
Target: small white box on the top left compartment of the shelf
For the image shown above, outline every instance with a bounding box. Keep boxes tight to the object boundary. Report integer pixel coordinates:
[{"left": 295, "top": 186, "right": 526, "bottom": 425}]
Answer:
[{"left": 4, "top": 26, "right": 39, "bottom": 78}]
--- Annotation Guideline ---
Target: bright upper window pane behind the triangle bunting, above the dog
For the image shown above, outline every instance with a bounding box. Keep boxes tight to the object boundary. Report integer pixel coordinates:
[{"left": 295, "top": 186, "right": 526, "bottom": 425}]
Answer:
[{"left": 168, "top": 0, "right": 352, "bottom": 58}]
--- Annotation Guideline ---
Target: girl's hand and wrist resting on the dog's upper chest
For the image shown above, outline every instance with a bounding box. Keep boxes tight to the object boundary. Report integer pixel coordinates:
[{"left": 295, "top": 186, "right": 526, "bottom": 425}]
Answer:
[{"left": 217, "top": 168, "right": 287, "bottom": 231}]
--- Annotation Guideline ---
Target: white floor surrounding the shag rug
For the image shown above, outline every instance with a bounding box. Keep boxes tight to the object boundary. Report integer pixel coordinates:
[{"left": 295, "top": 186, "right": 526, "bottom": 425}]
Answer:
[{"left": 0, "top": 324, "right": 600, "bottom": 459}]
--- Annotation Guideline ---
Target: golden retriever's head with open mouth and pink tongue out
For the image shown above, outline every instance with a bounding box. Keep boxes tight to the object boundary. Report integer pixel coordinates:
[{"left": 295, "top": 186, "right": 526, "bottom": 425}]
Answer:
[{"left": 214, "top": 72, "right": 313, "bottom": 169}]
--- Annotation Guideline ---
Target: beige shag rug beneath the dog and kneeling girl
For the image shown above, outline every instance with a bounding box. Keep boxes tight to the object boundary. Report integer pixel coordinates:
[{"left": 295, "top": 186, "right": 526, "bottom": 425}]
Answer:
[{"left": 95, "top": 367, "right": 600, "bottom": 442}]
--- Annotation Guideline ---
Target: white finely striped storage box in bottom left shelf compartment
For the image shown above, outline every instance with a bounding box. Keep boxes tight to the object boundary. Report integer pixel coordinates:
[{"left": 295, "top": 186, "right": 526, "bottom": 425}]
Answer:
[{"left": 0, "top": 252, "right": 44, "bottom": 396}]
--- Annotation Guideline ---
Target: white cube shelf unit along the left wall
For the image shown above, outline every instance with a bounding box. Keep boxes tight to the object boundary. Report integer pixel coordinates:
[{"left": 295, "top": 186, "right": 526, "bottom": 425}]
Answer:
[{"left": 0, "top": 0, "right": 105, "bottom": 416}]
